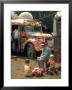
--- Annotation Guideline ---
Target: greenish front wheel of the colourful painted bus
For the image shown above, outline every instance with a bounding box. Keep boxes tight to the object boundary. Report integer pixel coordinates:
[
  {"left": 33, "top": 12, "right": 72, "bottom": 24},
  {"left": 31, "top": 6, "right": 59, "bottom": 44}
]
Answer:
[{"left": 27, "top": 44, "right": 36, "bottom": 59}]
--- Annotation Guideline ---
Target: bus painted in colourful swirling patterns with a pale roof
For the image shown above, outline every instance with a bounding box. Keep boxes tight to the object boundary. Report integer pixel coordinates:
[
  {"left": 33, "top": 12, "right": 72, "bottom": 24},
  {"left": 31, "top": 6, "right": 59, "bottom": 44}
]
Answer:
[{"left": 11, "top": 19, "right": 52, "bottom": 58}]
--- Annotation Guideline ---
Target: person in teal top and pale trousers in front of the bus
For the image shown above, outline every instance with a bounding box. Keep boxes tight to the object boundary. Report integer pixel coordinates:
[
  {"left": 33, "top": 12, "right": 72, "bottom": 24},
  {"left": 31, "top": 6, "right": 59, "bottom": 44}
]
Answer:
[{"left": 37, "top": 40, "right": 51, "bottom": 71}]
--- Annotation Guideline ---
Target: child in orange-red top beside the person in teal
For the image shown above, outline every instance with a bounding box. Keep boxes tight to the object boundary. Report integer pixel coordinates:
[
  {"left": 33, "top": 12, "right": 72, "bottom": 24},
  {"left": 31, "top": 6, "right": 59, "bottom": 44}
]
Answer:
[{"left": 47, "top": 54, "right": 57, "bottom": 75}]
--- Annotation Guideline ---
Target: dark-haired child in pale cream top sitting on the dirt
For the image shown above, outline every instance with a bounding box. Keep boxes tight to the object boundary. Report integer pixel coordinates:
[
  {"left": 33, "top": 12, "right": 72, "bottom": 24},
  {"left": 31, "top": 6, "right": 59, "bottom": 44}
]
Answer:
[{"left": 24, "top": 60, "right": 33, "bottom": 77}]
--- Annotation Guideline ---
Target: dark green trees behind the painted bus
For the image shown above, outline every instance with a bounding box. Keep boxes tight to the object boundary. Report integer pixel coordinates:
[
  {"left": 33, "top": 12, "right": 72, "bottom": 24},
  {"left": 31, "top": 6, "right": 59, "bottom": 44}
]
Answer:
[{"left": 15, "top": 11, "right": 57, "bottom": 32}]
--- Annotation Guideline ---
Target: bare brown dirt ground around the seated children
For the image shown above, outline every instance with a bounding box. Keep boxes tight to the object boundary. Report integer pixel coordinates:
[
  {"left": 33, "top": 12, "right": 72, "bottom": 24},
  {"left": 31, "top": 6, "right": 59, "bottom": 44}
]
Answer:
[{"left": 11, "top": 57, "right": 61, "bottom": 79}]
